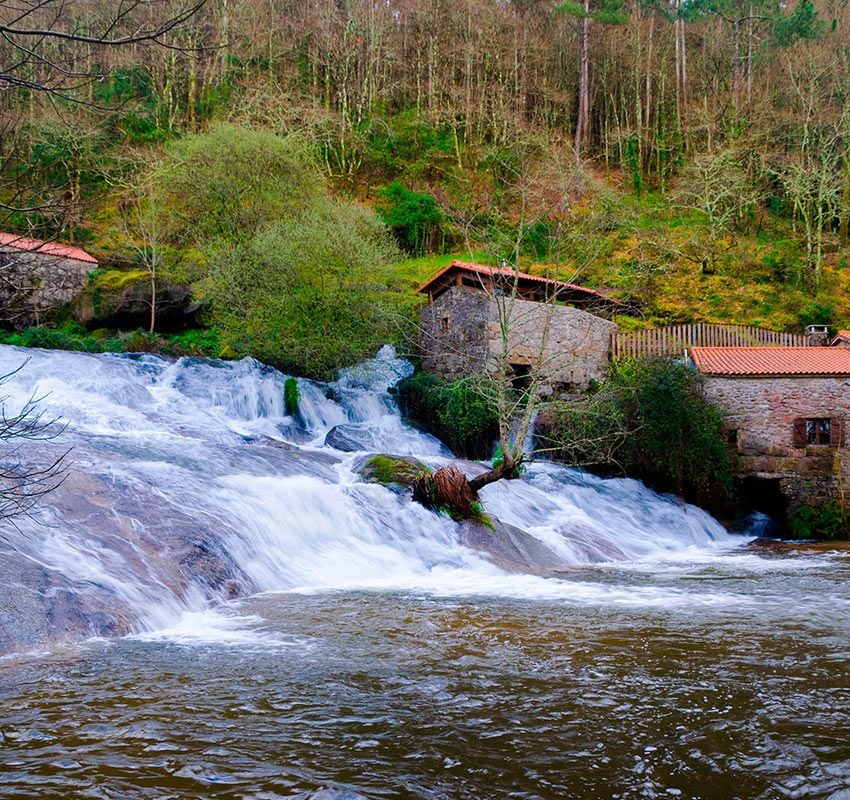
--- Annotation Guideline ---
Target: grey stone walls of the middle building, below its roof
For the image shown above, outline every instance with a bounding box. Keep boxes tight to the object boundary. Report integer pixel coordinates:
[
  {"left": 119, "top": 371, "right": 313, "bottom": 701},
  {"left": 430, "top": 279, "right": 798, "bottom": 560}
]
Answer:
[{"left": 420, "top": 286, "right": 617, "bottom": 388}]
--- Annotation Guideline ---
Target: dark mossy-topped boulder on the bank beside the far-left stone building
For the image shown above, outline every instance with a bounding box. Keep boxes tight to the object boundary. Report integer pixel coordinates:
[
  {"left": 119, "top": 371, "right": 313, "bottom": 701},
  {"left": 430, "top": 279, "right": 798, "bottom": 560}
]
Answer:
[{"left": 72, "top": 269, "right": 203, "bottom": 332}]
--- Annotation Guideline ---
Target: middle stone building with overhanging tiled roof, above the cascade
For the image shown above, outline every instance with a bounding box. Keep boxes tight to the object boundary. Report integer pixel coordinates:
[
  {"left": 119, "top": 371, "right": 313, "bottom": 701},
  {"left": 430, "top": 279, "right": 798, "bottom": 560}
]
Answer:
[{"left": 419, "top": 261, "right": 624, "bottom": 391}]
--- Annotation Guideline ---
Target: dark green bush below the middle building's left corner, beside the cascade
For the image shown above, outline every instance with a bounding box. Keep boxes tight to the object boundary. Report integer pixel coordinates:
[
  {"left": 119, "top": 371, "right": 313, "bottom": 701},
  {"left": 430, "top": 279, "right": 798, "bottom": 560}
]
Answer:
[{"left": 396, "top": 372, "right": 499, "bottom": 458}]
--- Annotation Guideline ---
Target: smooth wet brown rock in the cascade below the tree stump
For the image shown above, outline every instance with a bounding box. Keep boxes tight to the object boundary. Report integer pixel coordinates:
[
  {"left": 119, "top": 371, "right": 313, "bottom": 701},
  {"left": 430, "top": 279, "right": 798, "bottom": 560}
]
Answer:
[{"left": 458, "top": 518, "right": 570, "bottom": 575}]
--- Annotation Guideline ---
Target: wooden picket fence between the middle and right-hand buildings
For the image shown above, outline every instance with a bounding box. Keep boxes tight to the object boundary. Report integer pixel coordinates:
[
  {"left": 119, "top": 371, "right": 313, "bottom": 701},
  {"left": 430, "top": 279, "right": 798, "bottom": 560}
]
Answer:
[{"left": 611, "top": 322, "right": 822, "bottom": 360}]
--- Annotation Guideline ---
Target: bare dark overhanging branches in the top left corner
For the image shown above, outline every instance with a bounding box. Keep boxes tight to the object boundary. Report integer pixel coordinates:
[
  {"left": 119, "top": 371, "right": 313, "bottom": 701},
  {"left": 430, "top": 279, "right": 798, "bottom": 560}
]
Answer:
[{"left": 0, "top": 0, "right": 206, "bottom": 219}]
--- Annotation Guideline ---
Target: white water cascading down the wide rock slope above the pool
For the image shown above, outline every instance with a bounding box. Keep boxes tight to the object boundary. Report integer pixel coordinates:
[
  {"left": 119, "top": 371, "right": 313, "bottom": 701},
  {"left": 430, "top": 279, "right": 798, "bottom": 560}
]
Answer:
[{"left": 0, "top": 346, "right": 740, "bottom": 649}]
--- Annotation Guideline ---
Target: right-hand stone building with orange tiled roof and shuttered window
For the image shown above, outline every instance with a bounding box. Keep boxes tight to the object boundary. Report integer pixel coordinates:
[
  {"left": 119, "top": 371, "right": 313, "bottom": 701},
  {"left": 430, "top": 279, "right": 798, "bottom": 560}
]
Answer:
[{"left": 689, "top": 347, "right": 850, "bottom": 516}]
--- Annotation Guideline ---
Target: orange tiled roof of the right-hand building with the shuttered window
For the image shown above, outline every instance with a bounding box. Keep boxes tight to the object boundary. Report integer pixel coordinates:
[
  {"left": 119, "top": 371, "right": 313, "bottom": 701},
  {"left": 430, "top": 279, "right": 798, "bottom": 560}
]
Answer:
[{"left": 688, "top": 347, "right": 850, "bottom": 376}]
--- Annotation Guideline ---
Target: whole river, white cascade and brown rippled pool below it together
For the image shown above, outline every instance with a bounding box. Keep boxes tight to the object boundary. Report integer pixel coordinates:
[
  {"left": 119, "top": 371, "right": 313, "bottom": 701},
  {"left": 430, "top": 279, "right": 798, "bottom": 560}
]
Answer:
[{"left": 0, "top": 347, "right": 850, "bottom": 800}]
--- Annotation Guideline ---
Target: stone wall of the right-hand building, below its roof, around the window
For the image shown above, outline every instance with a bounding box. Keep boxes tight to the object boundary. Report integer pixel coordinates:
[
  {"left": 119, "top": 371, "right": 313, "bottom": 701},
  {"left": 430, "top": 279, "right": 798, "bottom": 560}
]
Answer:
[{"left": 704, "top": 376, "right": 850, "bottom": 508}]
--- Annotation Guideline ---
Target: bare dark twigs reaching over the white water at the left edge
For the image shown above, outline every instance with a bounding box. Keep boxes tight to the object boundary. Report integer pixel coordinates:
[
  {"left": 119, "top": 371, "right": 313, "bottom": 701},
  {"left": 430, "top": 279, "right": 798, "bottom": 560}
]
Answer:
[{"left": 0, "top": 361, "right": 70, "bottom": 524}]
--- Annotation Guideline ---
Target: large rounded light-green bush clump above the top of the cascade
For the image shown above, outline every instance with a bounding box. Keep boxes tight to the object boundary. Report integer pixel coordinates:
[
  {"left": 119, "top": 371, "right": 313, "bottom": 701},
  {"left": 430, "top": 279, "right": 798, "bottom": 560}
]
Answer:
[{"left": 152, "top": 125, "right": 418, "bottom": 379}]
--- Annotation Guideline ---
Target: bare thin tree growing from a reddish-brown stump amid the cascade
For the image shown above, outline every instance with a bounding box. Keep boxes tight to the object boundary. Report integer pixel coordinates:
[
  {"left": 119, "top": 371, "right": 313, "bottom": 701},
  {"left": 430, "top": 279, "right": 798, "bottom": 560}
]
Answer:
[{"left": 414, "top": 144, "right": 616, "bottom": 516}]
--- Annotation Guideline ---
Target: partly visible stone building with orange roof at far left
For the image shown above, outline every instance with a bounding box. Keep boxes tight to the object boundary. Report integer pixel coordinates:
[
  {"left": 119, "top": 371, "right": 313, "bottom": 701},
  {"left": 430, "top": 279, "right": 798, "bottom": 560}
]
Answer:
[{"left": 0, "top": 233, "right": 97, "bottom": 328}]
